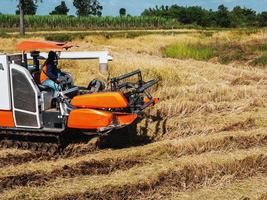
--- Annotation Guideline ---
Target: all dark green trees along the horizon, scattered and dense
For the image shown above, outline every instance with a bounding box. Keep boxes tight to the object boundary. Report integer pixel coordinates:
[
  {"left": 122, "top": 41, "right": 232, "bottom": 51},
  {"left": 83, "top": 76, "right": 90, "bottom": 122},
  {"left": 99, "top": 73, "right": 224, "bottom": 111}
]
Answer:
[{"left": 11, "top": 0, "right": 267, "bottom": 28}]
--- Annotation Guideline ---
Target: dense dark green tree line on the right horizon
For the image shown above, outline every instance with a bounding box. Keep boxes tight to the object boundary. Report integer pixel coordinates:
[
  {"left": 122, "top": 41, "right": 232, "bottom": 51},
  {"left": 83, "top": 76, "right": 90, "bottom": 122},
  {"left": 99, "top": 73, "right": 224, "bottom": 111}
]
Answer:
[{"left": 141, "top": 4, "right": 267, "bottom": 28}]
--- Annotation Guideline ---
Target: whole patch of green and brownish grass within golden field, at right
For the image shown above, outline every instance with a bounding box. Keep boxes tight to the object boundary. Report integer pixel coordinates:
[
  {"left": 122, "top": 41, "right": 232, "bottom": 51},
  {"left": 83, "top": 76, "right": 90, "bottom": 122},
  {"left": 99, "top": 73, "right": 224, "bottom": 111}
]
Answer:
[{"left": 162, "top": 38, "right": 267, "bottom": 66}]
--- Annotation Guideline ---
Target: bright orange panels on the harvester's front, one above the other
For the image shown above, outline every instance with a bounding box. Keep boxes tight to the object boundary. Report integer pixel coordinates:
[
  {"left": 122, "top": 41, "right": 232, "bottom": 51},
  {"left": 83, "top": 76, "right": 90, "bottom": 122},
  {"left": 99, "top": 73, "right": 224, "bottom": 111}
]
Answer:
[{"left": 68, "top": 92, "right": 137, "bottom": 129}]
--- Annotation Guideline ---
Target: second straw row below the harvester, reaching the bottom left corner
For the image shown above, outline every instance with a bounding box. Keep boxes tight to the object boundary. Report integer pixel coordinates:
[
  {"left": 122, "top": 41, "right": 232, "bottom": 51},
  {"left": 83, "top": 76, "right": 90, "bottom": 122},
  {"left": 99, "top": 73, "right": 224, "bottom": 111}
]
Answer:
[{"left": 3, "top": 148, "right": 267, "bottom": 199}]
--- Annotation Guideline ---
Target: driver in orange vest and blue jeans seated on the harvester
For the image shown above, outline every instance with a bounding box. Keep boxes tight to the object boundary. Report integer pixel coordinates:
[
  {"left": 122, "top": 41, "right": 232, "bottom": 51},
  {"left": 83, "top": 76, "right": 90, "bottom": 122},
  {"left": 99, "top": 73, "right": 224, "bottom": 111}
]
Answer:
[{"left": 40, "top": 51, "right": 63, "bottom": 97}]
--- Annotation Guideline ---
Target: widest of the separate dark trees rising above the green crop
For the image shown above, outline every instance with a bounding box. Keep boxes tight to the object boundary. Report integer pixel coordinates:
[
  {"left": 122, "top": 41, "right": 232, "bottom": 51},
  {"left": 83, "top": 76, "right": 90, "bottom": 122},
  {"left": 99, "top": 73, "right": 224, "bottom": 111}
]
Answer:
[{"left": 73, "top": 0, "right": 103, "bottom": 16}]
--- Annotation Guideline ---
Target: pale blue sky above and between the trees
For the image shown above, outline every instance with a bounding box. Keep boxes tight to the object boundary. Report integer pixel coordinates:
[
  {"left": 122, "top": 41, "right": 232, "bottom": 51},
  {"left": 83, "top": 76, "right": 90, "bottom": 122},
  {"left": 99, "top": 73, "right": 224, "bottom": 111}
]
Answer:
[{"left": 0, "top": 0, "right": 267, "bottom": 16}]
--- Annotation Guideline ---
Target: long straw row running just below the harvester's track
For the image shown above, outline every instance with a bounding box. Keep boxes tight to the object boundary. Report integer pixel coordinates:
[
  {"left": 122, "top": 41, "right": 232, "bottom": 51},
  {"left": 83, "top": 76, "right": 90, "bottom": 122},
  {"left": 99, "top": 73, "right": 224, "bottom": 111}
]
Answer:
[{"left": 0, "top": 129, "right": 267, "bottom": 178}]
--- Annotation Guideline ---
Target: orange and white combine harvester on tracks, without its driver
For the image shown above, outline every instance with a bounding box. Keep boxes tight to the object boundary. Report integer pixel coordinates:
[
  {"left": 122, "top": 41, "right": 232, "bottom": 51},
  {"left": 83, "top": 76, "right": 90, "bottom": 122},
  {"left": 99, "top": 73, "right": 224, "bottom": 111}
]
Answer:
[{"left": 0, "top": 41, "right": 158, "bottom": 153}]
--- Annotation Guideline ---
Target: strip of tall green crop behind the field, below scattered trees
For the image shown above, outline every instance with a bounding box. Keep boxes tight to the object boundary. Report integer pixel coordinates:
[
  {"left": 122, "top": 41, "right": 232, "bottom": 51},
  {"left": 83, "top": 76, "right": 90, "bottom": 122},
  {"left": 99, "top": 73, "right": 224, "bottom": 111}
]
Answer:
[{"left": 0, "top": 15, "right": 178, "bottom": 30}]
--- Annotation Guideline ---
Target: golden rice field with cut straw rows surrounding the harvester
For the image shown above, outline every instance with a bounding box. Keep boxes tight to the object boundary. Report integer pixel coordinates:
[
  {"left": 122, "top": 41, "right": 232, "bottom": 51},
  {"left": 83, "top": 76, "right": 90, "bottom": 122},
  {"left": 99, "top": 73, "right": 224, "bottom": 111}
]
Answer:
[{"left": 0, "top": 30, "right": 267, "bottom": 200}]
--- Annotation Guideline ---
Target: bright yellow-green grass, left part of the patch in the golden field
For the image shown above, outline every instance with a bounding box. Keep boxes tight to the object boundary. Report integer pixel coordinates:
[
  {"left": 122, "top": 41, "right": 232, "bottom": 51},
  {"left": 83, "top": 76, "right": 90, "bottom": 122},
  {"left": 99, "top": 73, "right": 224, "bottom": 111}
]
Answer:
[{"left": 163, "top": 44, "right": 214, "bottom": 60}]
